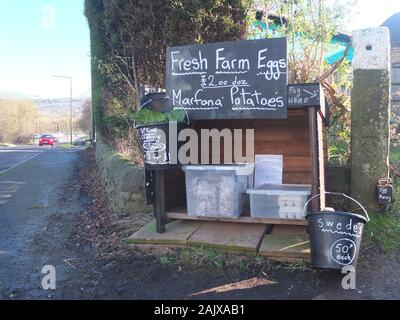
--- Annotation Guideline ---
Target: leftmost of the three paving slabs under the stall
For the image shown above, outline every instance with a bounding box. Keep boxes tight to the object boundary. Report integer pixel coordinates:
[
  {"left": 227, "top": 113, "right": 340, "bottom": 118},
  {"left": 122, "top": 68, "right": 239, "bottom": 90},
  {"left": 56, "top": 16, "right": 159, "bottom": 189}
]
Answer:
[{"left": 127, "top": 221, "right": 201, "bottom": 245}]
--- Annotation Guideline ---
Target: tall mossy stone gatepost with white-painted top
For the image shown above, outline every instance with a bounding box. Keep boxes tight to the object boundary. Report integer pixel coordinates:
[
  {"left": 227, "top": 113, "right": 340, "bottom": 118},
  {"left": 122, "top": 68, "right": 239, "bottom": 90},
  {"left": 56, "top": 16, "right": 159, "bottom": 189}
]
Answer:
[{"left": 350, "top": 27, "right": 391, "bottom": 212}]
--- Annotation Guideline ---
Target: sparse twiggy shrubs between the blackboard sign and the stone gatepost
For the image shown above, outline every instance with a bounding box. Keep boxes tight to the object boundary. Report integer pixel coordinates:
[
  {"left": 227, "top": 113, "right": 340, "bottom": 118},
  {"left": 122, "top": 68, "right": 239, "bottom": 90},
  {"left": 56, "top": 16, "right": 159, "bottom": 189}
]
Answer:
[{"left": 247, "top": 0, "right": 352, "bottom": 165}]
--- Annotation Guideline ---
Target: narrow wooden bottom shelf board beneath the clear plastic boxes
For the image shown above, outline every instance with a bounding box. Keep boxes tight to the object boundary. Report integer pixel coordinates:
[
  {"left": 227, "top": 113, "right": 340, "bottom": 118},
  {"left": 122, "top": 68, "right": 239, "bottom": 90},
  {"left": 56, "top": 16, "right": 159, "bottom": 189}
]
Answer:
[{"left": 167, "top": 211, "right": 308, "bottom": 226}]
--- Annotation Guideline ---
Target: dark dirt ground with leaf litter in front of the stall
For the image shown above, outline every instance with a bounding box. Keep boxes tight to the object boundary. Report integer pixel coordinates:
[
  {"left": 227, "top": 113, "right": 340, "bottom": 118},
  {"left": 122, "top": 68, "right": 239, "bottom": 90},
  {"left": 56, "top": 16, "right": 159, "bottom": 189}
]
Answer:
[{"left": 68, "top": 151, "right": 400, "bottom": 300}]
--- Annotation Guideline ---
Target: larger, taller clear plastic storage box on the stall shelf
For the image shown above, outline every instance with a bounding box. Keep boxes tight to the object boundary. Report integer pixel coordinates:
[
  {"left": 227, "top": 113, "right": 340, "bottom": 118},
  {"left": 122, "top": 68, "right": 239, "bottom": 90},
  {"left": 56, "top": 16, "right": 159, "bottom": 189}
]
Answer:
[{"left": 183, "top": 164, "right": 254, "bottom": 219}]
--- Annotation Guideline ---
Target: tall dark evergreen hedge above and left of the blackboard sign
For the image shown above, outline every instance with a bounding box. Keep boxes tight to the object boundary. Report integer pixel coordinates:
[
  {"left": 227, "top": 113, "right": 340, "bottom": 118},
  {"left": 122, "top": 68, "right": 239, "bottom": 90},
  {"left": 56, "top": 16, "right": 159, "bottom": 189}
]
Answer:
[{"left": 85, "top": 0, "right": 249, "bottom": 139}]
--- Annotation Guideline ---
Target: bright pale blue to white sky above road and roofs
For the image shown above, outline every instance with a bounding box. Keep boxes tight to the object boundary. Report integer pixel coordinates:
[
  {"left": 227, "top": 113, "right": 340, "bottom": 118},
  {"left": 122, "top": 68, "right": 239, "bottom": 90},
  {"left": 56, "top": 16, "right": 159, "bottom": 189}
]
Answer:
[{"left": 0, "top": 0, "right": 400, "bottom": 98}]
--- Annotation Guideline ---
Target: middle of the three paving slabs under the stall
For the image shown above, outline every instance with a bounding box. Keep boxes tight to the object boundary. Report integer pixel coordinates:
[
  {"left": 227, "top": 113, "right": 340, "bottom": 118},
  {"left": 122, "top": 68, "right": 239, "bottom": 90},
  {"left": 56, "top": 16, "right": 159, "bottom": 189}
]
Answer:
[{"left": 188, "top": 222, "right": 267, "bottom": 253}]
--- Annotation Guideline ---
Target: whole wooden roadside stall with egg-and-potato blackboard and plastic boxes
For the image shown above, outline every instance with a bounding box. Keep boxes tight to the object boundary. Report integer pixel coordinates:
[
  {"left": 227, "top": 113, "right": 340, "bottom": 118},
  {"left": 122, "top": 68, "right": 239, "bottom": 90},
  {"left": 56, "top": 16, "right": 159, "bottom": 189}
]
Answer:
[{"left": 140, "top": 38, "right": 329, "bottom": 238}]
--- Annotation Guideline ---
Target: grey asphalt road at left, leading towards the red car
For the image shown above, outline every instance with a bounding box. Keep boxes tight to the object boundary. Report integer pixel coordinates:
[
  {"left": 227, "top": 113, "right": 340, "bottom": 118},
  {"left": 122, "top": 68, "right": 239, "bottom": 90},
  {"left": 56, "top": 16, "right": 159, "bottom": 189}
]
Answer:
[{"left": 0, "top": 148, "right": 91, "bottom": 299}]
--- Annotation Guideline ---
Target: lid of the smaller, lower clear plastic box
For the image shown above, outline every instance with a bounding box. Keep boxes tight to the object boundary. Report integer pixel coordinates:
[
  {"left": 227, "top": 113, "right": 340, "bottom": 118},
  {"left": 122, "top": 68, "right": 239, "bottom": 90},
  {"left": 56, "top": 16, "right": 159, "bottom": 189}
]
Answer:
[{"left": 247, "top": 184, "right": 311, "bottom": 196}]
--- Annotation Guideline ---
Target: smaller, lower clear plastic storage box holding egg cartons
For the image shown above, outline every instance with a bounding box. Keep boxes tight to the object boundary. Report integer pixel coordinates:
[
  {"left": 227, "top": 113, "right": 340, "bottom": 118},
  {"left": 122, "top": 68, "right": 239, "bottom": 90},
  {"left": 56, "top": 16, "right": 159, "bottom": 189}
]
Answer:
[{"left": 247, "top": 184, "right": 311, "bottom": 220}]
